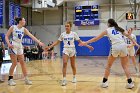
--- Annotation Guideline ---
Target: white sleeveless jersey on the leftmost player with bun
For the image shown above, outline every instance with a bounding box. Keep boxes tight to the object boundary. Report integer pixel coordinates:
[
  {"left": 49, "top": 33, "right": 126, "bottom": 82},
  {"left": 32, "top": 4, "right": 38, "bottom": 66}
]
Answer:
[{"left": 12, "top": 25, "right": 24, "bottom": 43}]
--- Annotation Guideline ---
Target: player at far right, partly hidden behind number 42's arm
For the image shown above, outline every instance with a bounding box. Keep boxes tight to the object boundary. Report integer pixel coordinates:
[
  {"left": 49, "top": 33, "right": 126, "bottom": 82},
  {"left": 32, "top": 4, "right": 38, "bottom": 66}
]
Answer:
[{"left": 124, "top": 28, "right": 138, "bottom": 73}]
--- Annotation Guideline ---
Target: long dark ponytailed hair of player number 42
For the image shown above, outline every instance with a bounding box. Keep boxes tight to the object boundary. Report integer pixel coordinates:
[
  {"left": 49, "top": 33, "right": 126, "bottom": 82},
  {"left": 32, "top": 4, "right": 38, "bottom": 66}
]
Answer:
[{"left": 108, "top": 19, "right": 125, "bottom": 33}]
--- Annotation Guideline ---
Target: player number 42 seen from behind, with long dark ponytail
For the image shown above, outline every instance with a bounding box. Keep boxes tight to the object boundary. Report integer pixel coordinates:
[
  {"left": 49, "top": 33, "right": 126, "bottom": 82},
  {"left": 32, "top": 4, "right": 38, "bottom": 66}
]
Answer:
[{"left": 81, "top": 19, "right": 138, "bottom": 89}]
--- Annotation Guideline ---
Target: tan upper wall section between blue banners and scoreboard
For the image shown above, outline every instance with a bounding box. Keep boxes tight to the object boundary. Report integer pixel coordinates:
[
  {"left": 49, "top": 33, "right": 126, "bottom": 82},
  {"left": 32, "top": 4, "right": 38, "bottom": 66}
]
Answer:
[{"left": 32, "top": 6, "right": 63, "bottom": 26}]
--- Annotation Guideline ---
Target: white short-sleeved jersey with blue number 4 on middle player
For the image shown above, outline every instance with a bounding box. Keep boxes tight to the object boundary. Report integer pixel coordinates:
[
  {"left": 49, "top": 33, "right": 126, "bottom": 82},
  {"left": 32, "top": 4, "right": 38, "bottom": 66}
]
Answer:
[{"left": 58, "top": 31, "right": 80, "bottom": 48}]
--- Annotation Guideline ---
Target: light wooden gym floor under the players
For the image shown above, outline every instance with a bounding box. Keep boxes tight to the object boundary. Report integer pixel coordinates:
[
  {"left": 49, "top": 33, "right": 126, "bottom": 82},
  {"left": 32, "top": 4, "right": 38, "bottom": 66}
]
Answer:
[{"left": 0, "top": 57, "right": 140, "bottom": 93}]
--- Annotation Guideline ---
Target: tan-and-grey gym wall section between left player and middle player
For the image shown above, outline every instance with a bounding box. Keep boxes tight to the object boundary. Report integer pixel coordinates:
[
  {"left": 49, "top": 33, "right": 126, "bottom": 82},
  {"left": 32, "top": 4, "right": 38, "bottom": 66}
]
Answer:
[{"left": 28, "top": 7, "right": 63, "bottom": 56}]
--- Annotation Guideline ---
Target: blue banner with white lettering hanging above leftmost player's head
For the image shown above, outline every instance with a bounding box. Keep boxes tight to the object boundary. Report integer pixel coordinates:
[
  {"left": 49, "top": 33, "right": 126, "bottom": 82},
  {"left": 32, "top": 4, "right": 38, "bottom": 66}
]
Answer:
[{"left": 9, "top": 2, "right": 21, "bottom": 26}]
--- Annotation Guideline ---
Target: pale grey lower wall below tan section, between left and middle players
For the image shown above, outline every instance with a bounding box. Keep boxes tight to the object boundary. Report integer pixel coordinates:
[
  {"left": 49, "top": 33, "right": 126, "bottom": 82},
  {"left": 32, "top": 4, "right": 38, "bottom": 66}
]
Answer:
[{"left": 28, "top": 25, "right": 61, "bottom": 56}]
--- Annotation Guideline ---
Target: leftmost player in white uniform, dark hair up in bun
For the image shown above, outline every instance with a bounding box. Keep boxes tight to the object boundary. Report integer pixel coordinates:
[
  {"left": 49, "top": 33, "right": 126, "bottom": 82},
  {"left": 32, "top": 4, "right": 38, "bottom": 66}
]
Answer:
[{"left": 5, "top": 18, "right": 44, "bottom": 86}]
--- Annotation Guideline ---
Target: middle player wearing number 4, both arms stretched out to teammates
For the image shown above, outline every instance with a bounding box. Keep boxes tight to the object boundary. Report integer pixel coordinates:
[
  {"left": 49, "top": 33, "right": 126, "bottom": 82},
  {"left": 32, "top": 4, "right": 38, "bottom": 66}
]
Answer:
[{"left": 47, "top": 22, "right": 93, "bottom": 86}]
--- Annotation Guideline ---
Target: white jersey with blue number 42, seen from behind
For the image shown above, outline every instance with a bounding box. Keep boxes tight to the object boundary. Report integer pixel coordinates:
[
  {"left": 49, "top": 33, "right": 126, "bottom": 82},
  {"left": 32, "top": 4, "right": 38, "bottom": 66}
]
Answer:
[{"left": 107, "top": 27, "right": 125, "bottom": 44}]
